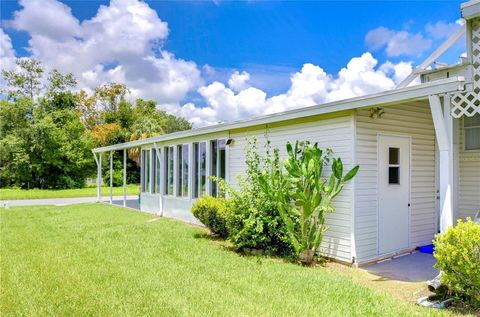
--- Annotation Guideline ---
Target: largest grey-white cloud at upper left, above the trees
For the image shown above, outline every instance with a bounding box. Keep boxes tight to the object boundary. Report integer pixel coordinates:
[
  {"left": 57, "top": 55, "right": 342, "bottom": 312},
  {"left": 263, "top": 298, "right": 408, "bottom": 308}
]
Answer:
[{"left": 8, "top": 0, "right": 203, "bottom": 103}]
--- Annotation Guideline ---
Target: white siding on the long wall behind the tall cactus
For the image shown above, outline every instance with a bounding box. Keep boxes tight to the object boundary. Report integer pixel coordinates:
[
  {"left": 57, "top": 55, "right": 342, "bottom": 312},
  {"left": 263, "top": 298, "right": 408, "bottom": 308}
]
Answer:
[{"left": 229, "top": 113, "right": 354, "bottom": 262}]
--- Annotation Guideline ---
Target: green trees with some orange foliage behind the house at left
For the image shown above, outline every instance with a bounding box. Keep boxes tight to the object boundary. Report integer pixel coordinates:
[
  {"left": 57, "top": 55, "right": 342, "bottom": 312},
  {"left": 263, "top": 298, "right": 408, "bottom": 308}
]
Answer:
[{"left": 0, "top": 58, "right": 191, "bottom": 189}]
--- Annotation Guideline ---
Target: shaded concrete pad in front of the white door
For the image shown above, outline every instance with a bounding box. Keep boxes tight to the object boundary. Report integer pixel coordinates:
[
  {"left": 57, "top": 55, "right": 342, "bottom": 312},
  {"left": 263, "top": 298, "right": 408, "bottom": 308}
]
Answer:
[{"left": 362, "top": 252, "right": 439, "bottom": 282}]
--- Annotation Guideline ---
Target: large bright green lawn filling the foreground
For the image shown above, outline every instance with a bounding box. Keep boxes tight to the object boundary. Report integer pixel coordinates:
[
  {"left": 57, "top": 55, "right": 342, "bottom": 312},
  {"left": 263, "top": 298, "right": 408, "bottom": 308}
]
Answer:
[{"left": 0, "top": 204, "right": 445, "bottom": 316}]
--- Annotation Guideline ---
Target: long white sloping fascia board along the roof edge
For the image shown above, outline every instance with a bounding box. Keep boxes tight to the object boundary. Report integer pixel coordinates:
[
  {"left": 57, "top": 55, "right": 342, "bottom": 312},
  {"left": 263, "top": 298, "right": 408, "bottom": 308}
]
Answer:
[{"left": 93, "top": 76, "right": 465, "bottom": 153}]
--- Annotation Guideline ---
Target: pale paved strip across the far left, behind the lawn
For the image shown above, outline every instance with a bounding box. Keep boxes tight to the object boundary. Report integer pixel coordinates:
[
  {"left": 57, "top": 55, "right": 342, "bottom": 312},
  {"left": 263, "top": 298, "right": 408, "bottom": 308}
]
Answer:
[{"left": 0, "top": 196, "right": 140, "bottom": 209}]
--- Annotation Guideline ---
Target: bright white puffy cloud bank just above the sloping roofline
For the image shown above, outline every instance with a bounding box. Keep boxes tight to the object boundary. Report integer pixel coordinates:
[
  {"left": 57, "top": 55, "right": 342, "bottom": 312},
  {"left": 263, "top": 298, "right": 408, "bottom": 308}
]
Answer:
[{"left": 162, "top": 53, "right": 412, "bottom": 126}]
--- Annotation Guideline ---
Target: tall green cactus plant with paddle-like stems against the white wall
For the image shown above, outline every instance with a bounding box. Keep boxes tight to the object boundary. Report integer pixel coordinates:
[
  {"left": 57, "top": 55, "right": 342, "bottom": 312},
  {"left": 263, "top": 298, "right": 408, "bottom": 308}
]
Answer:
[{"left": 259, "top": 141, "right": 359, "bottom": 264}]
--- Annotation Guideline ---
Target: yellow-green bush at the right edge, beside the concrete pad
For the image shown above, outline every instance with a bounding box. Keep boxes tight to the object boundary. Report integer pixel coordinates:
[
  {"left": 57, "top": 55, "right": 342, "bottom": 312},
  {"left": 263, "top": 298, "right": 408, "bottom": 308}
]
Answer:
[{"left": 434, "top": 219, "right": 480, "bottom": 308}]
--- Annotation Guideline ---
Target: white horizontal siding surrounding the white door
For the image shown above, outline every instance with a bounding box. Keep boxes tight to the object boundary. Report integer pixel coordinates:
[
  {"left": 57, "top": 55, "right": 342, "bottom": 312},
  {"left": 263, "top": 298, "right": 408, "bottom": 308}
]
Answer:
[{"left": 355, "top": 102, "right": 436, "bottom": 262}]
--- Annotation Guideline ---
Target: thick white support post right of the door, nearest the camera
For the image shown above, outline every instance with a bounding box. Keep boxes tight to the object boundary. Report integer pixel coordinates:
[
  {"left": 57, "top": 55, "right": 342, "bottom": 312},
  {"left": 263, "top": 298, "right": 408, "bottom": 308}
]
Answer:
[{"left": 429, "top": 95, "right": 453, "bottom": 232}]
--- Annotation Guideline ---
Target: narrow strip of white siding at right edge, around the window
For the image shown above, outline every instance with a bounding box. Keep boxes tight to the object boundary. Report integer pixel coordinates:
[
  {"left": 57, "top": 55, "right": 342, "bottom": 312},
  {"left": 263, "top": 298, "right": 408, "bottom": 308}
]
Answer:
[{"left": 457, "top": 119, "right": 480, "bottom": 218}]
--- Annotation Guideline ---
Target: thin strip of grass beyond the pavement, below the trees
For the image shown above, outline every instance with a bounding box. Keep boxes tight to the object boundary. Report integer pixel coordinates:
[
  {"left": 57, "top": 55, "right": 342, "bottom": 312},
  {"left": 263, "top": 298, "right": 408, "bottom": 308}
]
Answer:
[{"left": 0, "top": 184, "right": 140, "bottom": 200}]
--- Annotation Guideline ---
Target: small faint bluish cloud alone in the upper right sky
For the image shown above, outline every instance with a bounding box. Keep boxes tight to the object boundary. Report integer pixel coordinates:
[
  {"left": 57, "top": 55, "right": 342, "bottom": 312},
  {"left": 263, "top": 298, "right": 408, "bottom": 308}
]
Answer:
[{"left": 365, "top": 26, "right": 433, "bottom": 57}]
